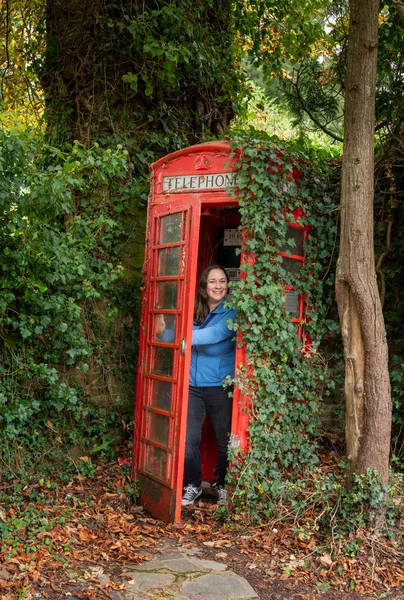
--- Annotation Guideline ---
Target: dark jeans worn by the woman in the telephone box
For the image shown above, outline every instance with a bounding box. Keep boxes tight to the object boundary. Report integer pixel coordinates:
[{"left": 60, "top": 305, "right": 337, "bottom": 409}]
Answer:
[{"left": 184, "top": 386, "right": 233, "bottom": 487}]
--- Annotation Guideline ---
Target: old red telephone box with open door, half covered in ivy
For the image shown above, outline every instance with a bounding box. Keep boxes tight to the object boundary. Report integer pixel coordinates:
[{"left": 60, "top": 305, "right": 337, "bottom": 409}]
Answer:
[{"left": 133, "top": 141, "right": 307, "bottom": 522}]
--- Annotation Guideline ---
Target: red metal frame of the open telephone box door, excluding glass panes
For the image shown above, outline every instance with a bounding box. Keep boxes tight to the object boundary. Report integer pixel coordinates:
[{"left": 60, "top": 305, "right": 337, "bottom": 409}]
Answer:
[{"left": 133, "top": 197, "right": 199, "bottom": 521}]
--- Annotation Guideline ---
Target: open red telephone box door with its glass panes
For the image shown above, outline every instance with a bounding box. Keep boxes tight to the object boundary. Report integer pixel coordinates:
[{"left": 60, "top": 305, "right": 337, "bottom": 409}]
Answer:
[{"left": 134, "top": 195, "right": 200, "bottom": 522}]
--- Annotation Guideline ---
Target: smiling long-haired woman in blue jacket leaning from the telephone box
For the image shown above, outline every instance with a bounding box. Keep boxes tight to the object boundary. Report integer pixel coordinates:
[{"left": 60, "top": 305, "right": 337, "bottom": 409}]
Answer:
[{"left": 182, "top": 265, "right": 236, "bottom": 506}]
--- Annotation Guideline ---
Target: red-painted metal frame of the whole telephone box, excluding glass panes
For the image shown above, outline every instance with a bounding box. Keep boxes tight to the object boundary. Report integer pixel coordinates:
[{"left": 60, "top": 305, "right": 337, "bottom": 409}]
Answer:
[{"left": 132, "top": 142, "right": 308, "bottom": 522}]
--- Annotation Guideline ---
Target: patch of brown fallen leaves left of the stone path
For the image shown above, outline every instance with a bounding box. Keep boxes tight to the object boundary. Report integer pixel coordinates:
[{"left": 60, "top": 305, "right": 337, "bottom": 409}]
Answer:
[{"left": 0, "top": 466, "right": 164, "bottom": 600}]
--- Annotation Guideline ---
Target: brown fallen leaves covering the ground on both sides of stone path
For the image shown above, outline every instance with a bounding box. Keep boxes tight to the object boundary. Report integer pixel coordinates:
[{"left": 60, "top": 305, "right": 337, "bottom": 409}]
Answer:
[{"left": 0, "top": 465, "right": 404, "bottom": 600}]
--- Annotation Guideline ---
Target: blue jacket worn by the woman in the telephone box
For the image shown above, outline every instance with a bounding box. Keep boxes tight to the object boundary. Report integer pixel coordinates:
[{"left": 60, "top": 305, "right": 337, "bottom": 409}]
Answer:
[{"left": 189, "top": 301, "right": 236, "bottom": 387}]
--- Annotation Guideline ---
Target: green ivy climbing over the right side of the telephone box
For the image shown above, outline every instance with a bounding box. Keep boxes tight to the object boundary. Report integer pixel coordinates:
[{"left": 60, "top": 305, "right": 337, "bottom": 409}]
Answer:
[{"left": 227, "top": 138, "right": 335, "bottom": 516}]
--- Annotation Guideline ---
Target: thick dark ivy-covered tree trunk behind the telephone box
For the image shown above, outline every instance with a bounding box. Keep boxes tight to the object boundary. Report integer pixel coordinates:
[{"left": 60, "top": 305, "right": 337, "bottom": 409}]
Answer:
[{"left": 41, "top": 0, "right": 237, "bottom": 422}]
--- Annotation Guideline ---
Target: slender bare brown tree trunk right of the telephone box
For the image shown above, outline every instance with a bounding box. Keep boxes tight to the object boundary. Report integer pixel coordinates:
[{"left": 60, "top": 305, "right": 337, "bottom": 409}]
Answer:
[{"left": 336, "top": 0, "right": 391, "bottom": 483}]
